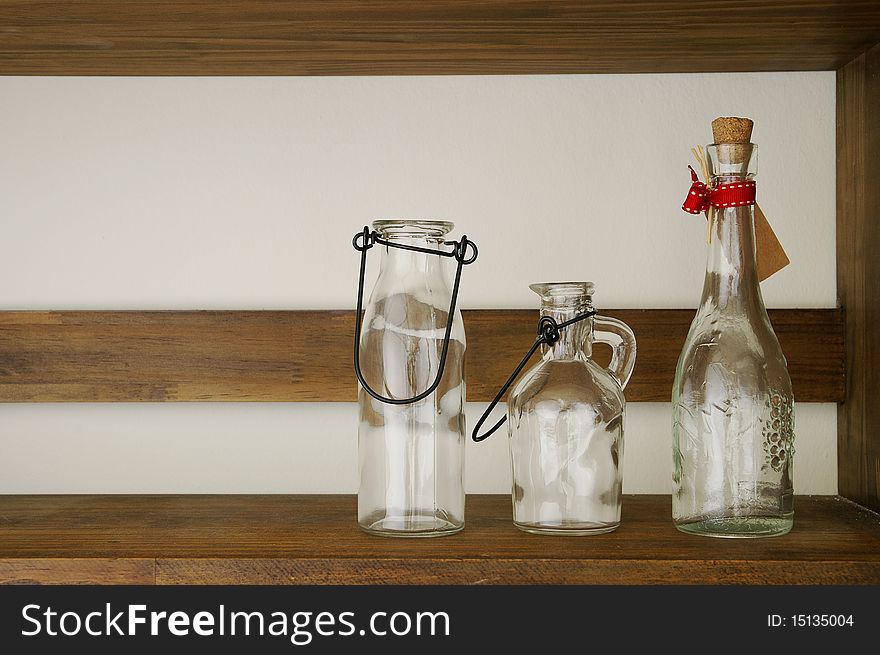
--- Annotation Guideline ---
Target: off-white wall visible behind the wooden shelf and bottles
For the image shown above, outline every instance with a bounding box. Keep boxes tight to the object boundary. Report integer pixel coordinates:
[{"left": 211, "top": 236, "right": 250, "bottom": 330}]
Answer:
[{"left": 0, "top": 72, "right": 837, "bottom": 493}]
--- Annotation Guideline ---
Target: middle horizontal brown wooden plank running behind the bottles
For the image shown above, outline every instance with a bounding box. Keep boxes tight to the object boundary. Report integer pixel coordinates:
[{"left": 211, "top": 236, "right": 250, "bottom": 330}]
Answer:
[{"left": 0, "top": 309, "right": 845, "bottom": 402}]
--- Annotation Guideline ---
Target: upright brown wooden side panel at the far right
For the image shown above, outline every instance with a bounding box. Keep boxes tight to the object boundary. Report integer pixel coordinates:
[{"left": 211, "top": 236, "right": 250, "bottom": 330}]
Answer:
[{"left": 837, "top": 45, "right": 880, "bottom": 510}]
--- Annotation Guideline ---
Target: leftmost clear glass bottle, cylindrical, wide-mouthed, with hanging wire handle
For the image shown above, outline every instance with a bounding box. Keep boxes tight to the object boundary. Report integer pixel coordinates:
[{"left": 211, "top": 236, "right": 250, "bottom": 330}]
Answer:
[{"left": 355, "top": 220, "right": 476, "bottom": 537}]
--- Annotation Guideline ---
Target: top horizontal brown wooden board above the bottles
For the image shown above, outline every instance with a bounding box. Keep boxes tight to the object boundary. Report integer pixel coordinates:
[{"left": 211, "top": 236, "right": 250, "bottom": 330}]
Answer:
[{"left": 0, "top": 0, "right": 880, "bottom": 75}]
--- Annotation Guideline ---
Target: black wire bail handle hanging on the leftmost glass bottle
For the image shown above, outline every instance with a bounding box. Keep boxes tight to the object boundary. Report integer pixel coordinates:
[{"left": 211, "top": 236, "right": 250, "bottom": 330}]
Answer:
[{"left": 351, "top": 225, "right": 479, "bottom": 405}]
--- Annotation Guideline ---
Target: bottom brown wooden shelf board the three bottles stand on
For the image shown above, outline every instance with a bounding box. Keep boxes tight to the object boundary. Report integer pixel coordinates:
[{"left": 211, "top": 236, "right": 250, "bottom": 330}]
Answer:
[{"left": 0, "top": 496, "right": 880, "bottom": 584}]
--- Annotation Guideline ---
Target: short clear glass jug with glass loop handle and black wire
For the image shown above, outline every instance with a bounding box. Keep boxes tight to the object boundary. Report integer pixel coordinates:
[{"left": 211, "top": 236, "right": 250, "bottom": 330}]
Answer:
[{"left": 474, "top": 282, "right": 636, "bottom": 535}]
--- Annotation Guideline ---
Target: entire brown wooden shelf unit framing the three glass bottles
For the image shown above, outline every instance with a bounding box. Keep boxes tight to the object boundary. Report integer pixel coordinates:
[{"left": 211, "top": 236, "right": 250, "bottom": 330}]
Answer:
[{"left": 0, "top": 0, "right": 880, "bottom": 584}]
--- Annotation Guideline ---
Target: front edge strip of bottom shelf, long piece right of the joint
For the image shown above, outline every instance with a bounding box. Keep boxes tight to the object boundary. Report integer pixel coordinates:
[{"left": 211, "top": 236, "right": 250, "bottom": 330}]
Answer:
[{"left": 156, "top": 558, "right": 880, "bottom": 585}]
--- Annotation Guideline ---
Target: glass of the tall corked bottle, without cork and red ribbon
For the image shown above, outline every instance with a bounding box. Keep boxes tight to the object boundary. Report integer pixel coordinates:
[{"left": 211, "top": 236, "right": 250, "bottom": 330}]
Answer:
[{"left": 672, "top": 143, "right": 794, "bottom": 537}]
